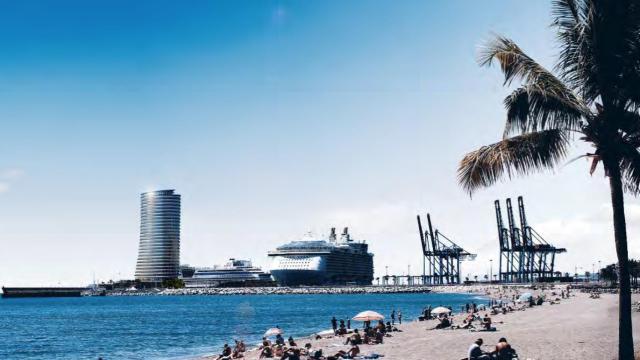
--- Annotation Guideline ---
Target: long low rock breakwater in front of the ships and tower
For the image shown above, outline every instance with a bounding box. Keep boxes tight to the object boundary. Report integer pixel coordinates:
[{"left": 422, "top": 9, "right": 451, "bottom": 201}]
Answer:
[{"left": 106, "top": 286, "right": 432, "bottom": 296}]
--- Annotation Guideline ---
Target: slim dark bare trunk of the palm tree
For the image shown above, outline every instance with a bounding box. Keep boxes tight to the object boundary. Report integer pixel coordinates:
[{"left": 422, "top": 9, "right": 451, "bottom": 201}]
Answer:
[{"left": 607, "top": 161, "right": 634, "bottom": 360}]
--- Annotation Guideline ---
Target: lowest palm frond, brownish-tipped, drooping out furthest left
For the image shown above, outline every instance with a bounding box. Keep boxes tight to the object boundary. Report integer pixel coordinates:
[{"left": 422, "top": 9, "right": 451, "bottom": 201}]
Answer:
[{"left": 458, "top": 129, "right": 569, "bottom": 194}]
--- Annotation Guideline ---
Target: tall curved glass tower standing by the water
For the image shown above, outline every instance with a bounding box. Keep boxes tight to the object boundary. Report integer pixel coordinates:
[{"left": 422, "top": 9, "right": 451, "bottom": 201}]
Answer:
[{"left": 136, "top": 190, "right": 180, "bottom": 282}]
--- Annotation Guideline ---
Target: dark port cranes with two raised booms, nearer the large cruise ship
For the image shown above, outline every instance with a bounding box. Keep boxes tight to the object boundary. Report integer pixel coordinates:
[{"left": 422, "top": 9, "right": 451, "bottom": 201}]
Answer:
[{"left": 417, "top": 214, "right": 476, "bottom": 285}]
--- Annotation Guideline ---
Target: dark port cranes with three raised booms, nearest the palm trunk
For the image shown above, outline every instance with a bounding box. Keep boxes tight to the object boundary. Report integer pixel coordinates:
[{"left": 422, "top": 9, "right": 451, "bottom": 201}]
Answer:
[{"left": 494, "top": 196, "right": 567, "bottom": 282}]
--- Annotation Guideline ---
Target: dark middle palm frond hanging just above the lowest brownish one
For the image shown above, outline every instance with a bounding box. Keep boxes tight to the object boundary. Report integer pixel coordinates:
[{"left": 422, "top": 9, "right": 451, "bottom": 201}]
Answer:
[{"left": 504, "top": 82, "right": 590, "bottom": 137}]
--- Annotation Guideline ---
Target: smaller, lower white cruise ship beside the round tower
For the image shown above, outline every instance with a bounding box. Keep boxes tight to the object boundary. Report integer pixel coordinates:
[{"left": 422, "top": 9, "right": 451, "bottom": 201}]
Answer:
[{"left": 183, "top": 259, "right": 273, "bottom": 287}]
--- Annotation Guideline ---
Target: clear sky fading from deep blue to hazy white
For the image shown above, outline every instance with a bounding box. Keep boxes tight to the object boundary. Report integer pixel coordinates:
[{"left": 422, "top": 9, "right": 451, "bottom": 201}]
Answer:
[{"left": 0, "top": 0, "right": 640, "bottom": 286}]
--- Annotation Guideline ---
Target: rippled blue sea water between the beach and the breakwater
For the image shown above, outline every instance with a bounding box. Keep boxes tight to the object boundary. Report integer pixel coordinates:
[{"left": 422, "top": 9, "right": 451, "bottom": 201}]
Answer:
[{"left": 0, "top": 294, "right": 486, "bottom": 360}]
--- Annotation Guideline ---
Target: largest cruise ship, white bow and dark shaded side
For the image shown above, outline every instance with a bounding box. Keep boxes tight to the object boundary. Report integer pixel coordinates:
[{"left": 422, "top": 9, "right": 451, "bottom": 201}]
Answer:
[{"left": 268, "top": 228, "right": 373, "bottom": 286}]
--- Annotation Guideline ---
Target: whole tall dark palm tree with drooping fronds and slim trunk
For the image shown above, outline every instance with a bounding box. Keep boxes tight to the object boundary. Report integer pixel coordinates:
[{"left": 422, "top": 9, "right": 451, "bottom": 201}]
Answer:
[{"left": 458, "top": 0, "right": 640, "bottom": 359}]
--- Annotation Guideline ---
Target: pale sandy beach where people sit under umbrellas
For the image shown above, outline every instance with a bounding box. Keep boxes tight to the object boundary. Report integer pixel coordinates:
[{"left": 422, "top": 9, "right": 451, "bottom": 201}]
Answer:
[{"left": 209, "top": 287, "right": 640, "bottom": 360}]
